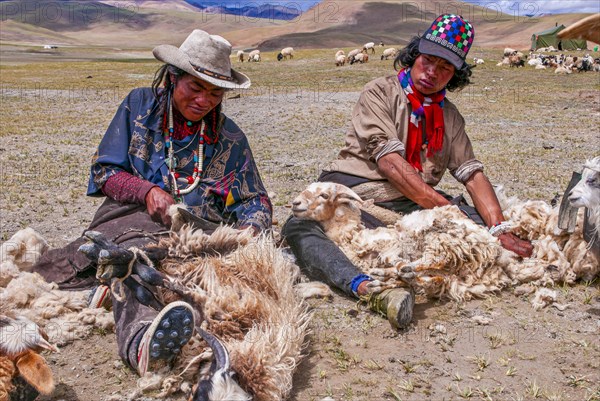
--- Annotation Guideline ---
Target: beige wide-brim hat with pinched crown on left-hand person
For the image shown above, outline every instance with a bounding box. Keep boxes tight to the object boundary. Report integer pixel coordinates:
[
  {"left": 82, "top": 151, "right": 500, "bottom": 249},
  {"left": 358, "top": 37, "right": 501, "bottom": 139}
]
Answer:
[{"left": 152, "top": 29, "right": 250, "bottom": 89}]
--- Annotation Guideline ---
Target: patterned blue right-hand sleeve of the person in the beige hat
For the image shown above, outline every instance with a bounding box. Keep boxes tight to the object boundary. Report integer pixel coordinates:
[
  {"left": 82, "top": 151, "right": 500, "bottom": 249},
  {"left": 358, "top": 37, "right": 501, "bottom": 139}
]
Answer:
[{"left": 225, "top": 137, "right": 273, "bottom": 231}]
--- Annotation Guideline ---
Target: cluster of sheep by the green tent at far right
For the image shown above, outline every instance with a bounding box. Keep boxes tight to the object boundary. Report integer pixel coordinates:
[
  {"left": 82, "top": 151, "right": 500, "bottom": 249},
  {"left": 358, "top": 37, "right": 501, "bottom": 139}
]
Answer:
[{"left": 497, "top": 46, "right": 600, "bottom": 74}]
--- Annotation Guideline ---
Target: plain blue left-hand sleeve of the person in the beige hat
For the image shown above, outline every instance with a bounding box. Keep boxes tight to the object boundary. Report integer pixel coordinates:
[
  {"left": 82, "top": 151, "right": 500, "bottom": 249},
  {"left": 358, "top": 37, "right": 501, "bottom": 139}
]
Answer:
[{"left": 87, "top": 93, "right": 133, "bottom": 196}]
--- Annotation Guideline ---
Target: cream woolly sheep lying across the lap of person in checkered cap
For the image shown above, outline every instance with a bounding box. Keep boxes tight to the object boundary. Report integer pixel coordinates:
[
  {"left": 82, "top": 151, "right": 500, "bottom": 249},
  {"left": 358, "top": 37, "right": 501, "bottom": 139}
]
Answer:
[{"left": 292, "top": 183, "right": 543, "bottom": 300}]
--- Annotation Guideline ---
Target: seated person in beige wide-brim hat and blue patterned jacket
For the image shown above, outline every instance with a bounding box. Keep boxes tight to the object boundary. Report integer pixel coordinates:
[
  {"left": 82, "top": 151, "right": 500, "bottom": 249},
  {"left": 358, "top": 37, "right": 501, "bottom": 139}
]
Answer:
[{"left": 34, "top": 30, "right": 272, "bottom": 375}]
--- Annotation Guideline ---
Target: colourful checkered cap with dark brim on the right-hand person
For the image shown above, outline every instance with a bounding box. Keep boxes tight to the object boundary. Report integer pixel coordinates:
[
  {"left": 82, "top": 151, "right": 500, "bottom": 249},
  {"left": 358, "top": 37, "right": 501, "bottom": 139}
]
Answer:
[{"left": 419, "top": 14, "right": 475, "bottom": 69}]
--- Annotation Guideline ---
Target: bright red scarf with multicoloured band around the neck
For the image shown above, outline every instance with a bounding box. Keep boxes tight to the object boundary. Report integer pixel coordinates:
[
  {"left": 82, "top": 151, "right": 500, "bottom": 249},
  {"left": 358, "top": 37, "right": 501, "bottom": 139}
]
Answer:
[{"left": 398, "top": 69, "right": 446, "bottom": 171}]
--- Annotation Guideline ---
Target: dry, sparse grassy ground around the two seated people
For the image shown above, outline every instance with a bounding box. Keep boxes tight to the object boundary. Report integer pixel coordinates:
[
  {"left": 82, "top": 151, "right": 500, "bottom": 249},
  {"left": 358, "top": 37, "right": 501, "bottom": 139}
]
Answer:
[{"left": 0, "top": 49, "right": 600, "bottom": 401}]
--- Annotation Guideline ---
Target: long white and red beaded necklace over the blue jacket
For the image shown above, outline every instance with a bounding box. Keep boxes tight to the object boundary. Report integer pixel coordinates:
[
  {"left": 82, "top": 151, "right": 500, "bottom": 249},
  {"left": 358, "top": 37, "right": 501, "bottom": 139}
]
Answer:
[{"left": 164, "top": 95, "right": 206, "bottom": 202}]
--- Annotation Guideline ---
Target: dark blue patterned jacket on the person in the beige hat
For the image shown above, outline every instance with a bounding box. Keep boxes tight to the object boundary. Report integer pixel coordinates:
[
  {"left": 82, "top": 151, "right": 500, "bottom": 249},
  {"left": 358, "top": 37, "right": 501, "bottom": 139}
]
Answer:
[{"left": 87, "top": 88, "right": 273, "bottom": 230}]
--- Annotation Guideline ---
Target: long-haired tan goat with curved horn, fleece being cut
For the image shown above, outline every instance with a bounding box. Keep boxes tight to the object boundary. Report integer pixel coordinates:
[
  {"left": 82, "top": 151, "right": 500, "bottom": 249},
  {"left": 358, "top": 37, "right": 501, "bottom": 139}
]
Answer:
[{"left": 81, "top": 222, "right": 311, "bottom": 401}]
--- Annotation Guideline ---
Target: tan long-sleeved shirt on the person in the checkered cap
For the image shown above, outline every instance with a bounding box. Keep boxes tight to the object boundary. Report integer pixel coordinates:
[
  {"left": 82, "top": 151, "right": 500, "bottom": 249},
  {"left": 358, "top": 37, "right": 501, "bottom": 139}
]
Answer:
[{"left": 323, "top": 75, "right": 483, "bottom": 201}]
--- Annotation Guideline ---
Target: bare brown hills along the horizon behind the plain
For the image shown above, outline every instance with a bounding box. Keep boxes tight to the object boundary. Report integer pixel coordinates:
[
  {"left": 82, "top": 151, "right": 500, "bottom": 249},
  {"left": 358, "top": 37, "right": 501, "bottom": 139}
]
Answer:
[{"left": 0, "top": 0, "right": 586, "bottom": 51}]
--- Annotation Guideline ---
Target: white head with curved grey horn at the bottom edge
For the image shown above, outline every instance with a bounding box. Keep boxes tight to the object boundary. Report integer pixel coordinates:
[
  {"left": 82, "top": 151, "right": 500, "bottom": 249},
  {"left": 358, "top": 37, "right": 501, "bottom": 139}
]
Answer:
[{"left": 189, "top": 329, "right": 252, "bottom": 401}]
